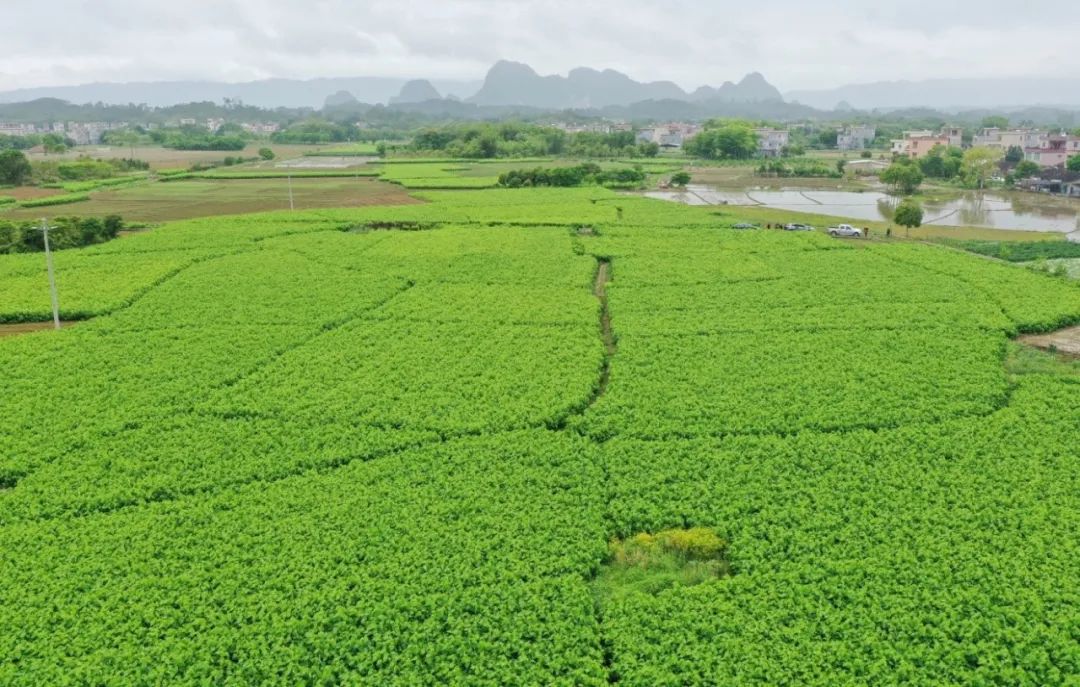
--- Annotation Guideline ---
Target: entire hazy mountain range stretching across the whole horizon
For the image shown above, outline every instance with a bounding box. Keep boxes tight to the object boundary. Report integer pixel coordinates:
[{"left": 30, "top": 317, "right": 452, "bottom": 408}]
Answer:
[{"left": 0, "top": 60, "right": 1080, "bottom": 119}]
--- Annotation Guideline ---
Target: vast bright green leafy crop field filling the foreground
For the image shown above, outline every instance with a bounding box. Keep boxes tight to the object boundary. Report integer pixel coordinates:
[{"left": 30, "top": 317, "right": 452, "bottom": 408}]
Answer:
[{"left": 0, "top": 184, "right": 1080, "bottom": 687}]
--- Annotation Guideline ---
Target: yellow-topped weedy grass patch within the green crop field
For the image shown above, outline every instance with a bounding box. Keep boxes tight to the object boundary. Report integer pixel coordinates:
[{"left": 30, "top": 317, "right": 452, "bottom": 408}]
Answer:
[{"left": 593, "top": 527, "right": 731, "bottom": 603}]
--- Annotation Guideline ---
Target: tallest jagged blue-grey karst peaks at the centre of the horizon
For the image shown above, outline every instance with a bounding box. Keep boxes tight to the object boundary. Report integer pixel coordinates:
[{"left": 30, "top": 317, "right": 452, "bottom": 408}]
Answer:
[{"left": 468, "top": 60, "right": 783, "bottom": 109}]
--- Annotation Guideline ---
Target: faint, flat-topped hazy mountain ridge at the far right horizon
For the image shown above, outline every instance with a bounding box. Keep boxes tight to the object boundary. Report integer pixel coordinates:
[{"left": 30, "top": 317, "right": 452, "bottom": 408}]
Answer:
[{"left": 785, "top": 78, "right": 1080, "bottom": 110}]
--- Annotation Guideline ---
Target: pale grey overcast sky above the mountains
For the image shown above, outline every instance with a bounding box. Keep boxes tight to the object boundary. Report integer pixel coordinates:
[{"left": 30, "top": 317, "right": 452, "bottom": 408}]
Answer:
[{"left": 0, "top": 0, "right": 1080, "bottom": 91}]
